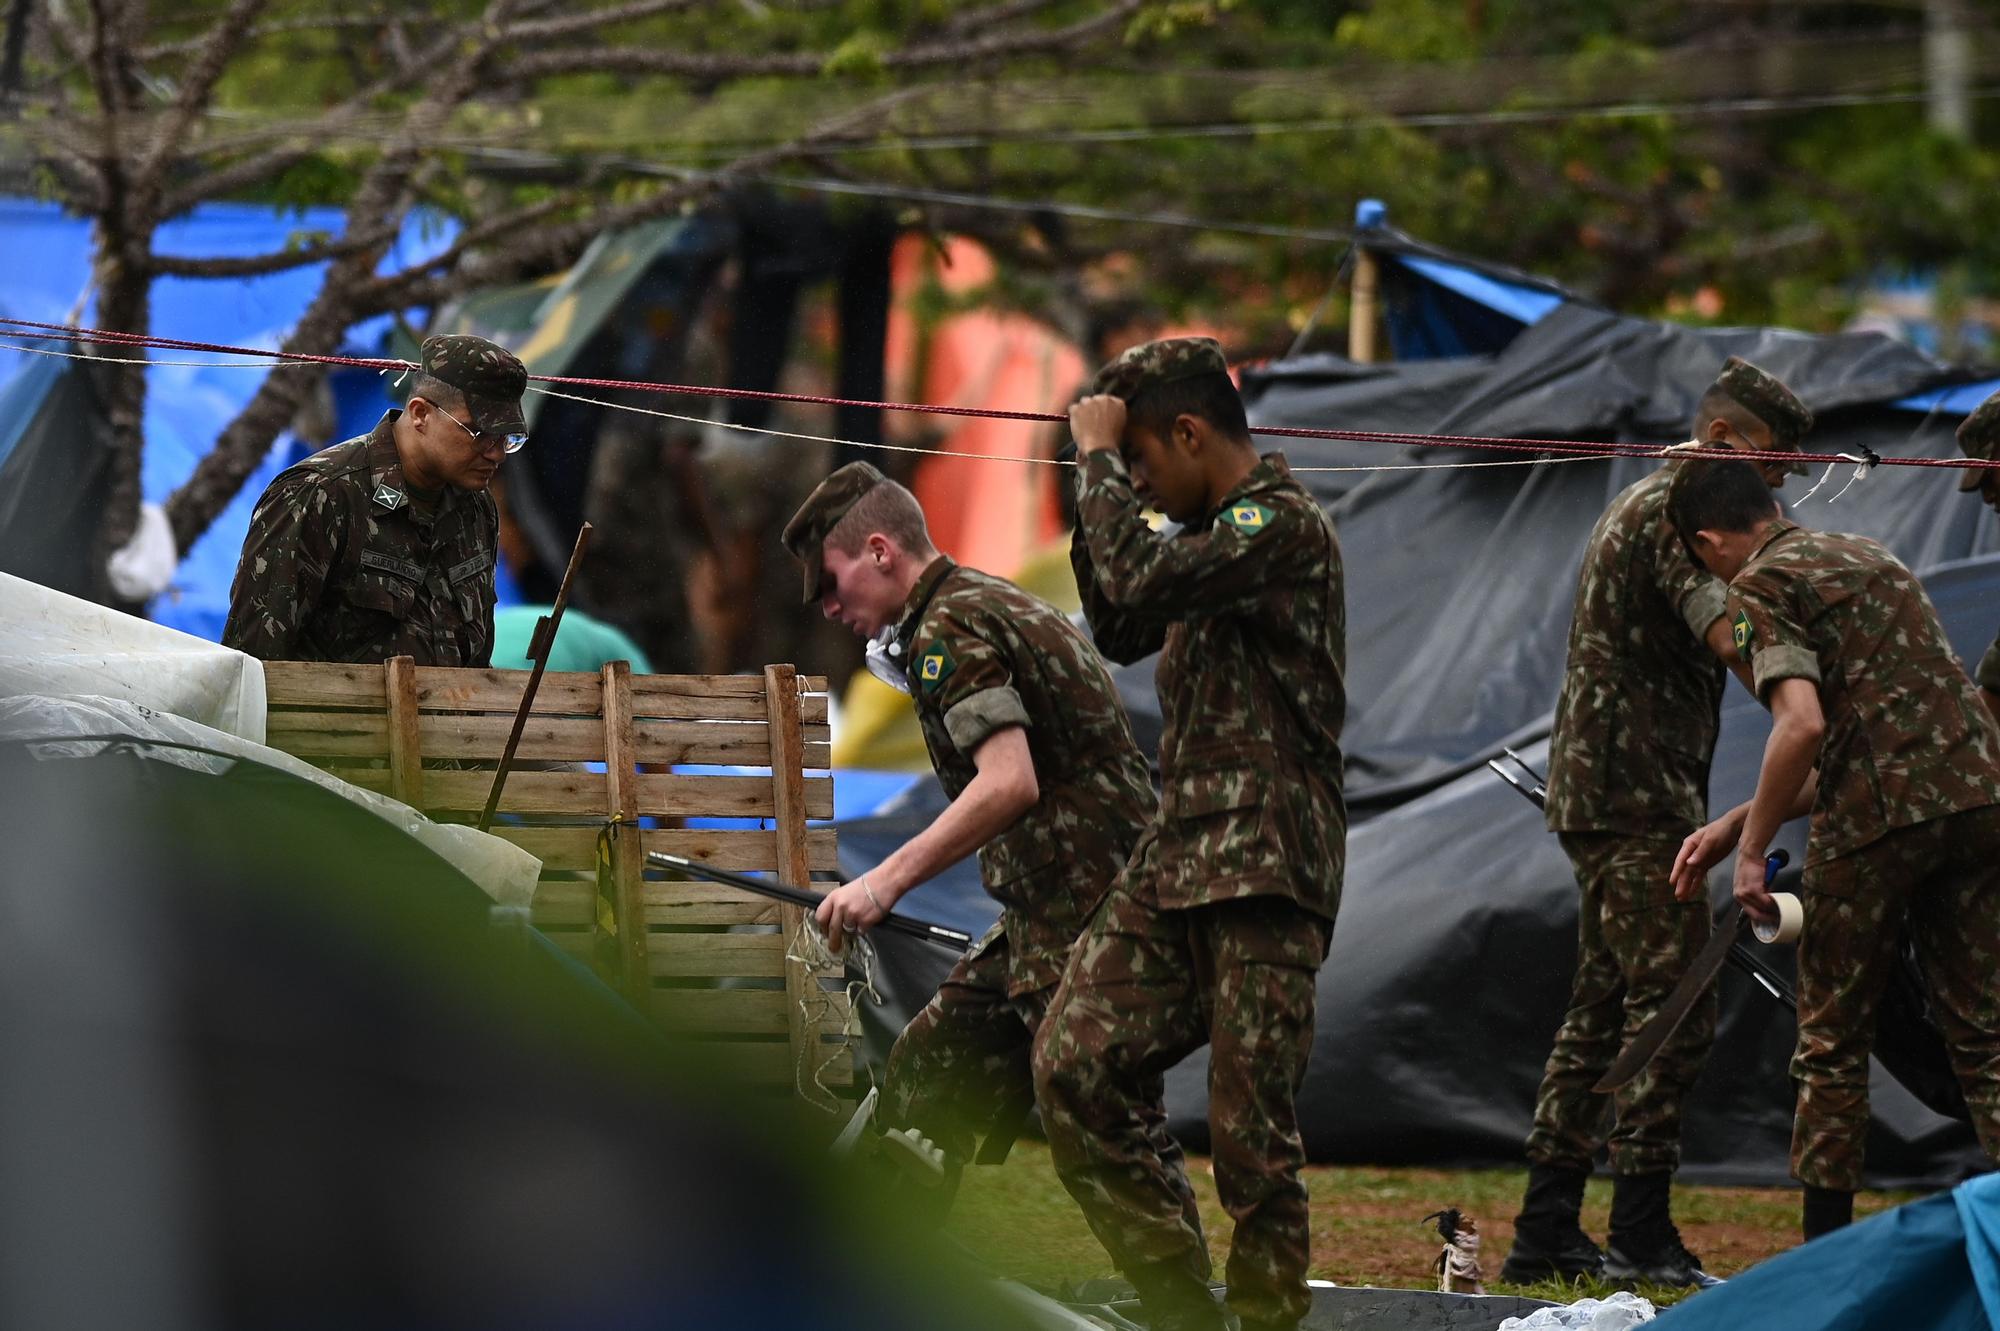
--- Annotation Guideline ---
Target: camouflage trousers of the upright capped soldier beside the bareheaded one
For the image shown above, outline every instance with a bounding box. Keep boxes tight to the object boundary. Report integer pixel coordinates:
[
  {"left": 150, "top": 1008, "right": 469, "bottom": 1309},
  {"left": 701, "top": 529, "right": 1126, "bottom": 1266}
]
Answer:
[{"left": 1528, "top": 831, "right": 1716, "bottom": 1173}]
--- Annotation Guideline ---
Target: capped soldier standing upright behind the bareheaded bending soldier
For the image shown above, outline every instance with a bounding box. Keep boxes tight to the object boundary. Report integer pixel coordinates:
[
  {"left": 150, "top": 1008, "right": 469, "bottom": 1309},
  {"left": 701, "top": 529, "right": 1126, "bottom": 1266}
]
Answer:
[{"left": 1502, "top": 356, "right": 1812, "bottom": 1285}]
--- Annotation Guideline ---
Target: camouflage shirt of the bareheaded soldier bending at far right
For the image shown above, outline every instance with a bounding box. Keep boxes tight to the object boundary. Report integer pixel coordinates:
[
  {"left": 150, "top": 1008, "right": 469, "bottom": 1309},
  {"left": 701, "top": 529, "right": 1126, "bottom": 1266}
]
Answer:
[{"left": 1728, "top": 520, "right": 2000, "bottom": 865}]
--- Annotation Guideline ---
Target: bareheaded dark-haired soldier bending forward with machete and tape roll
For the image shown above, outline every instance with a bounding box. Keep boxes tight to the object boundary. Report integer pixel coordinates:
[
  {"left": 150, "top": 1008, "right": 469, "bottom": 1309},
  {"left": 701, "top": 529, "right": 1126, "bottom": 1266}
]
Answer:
[{"left": 1672, "top": 464, "right": 2000, "bottom": 1239}]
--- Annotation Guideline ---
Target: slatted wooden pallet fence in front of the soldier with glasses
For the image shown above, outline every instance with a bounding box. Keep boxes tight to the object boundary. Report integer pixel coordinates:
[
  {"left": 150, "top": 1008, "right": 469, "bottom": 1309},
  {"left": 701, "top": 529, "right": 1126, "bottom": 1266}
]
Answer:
[{"left": 264, "top": 658, "right": 854, "bottom": 1107}]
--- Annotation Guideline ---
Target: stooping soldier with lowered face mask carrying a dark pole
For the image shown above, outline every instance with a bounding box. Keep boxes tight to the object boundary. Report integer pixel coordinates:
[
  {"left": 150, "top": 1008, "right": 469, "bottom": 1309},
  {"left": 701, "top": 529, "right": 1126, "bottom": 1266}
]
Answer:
[{"left": 784, "top": 462, "right": 1196, "bottom": 1215}]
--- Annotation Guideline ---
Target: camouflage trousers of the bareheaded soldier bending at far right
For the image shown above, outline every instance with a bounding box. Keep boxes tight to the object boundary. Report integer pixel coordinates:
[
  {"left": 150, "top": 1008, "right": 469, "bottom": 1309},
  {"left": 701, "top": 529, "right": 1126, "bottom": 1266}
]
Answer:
[{"left": 1792, "top": 805, "right": 2000, "bottom": 1191}]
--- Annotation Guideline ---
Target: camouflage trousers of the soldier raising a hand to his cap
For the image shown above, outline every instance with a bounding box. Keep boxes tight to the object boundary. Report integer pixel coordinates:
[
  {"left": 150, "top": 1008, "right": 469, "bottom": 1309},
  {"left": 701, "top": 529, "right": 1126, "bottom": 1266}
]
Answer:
[{"left": 1034, "top": 885, "right": 1332, "bottom": 1323}]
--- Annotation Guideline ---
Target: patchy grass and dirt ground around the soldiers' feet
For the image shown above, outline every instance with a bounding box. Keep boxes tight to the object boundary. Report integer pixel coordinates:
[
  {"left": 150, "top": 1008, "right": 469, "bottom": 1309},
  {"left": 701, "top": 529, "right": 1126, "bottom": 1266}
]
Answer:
[{"left": 950, "top": 1141, "right": 1916, "bottom": 1305}]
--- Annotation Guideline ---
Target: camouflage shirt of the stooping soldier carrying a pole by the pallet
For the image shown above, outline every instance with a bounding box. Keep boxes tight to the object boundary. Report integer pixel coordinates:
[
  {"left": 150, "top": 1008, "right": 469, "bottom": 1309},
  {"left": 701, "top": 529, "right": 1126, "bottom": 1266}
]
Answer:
[{"left": 896, "top": 556, "right": 1154, "bottom": 997}]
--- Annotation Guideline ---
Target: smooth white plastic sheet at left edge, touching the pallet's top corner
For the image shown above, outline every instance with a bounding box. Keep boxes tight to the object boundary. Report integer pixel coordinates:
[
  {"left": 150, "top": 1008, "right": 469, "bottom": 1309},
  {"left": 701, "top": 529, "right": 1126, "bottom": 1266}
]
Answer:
[{"left": 0, "top": 574, "right": 264, "bottom": 743}]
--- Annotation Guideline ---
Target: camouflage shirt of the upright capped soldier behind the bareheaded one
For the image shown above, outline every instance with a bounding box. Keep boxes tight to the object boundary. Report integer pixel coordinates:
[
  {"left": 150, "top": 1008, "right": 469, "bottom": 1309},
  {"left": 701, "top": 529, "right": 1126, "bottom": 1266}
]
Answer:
[{"left": 1548, "top": 464, "right": 1724, "bottom": 835}]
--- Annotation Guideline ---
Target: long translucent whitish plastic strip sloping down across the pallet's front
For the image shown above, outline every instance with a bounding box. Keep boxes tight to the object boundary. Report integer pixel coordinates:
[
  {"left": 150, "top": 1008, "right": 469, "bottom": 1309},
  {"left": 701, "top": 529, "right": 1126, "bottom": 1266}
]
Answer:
[{"left": 0, "top": 675, "right": 542, "bottom": 909}]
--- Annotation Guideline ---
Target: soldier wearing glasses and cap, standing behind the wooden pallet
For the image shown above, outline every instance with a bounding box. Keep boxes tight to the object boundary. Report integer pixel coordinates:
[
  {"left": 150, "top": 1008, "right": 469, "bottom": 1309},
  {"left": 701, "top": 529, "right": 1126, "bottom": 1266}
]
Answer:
[{"left": 222, "top": 336, "right": 528, "bottom": 666}]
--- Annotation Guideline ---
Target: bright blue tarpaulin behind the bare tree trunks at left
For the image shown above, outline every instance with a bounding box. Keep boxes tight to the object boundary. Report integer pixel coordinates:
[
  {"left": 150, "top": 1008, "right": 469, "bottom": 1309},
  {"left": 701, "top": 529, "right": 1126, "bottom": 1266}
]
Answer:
[{"left": 0, "top": 198, "right": 458, "bottom": 640}]
